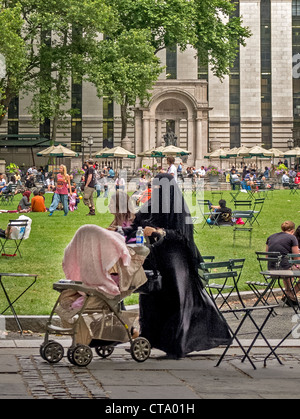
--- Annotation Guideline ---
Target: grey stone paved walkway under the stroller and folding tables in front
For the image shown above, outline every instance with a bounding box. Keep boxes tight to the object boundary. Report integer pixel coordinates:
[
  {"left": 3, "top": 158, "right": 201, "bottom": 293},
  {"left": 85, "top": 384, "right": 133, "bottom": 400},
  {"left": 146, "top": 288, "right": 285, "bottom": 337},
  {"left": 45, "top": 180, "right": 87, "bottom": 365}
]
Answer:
[{"left": 0, "top": 302, "right": 300, "bottom": 400}]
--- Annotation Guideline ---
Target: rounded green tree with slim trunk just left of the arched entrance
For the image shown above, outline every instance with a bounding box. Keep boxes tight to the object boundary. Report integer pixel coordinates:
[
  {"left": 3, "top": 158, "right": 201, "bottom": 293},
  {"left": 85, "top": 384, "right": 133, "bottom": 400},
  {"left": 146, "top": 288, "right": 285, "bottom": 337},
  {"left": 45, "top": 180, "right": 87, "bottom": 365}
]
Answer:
[{"left": 88, "top": 29, "right": 162, "bottom": 138}]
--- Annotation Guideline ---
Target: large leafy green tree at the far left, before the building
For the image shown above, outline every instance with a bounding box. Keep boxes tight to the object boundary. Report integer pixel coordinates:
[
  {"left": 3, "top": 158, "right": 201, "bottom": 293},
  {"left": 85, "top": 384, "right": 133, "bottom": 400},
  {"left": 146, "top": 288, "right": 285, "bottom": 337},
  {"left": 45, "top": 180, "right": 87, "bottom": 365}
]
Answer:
[{"left": 0, "top": 0, "right": 115, "bottom": 141}]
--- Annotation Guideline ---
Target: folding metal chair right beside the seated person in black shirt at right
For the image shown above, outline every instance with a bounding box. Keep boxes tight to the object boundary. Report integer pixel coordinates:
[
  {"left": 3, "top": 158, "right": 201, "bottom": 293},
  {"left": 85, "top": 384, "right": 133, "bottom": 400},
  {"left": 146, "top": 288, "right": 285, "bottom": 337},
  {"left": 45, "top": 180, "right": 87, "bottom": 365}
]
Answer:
[{"left": 246, "top": 252, "right": 281, "bottom": 306}]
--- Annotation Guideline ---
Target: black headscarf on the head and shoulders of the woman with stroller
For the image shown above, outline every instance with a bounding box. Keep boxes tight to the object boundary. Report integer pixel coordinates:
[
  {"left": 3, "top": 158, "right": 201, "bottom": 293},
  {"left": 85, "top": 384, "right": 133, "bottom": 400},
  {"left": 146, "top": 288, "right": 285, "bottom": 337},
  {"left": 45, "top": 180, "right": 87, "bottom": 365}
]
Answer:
[{"left": 134, "top": 173, "right": 203, "bottom": 265}]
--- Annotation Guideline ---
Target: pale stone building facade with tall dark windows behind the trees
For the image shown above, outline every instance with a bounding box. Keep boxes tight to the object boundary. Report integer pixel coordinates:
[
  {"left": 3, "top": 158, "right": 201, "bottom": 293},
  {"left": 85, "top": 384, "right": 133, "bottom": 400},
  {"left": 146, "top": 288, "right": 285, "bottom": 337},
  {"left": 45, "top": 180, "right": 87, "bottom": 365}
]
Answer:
[{"left": 0, "top": 0, "right": 300, "bottom": 171}]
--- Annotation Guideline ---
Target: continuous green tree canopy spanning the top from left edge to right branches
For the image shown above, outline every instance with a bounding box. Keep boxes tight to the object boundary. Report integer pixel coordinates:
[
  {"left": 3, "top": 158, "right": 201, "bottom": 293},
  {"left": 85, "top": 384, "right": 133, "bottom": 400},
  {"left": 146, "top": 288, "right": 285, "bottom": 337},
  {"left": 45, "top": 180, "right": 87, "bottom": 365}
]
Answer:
[{"left": 0, "top": 0, "right": 250, "bottom": 141}]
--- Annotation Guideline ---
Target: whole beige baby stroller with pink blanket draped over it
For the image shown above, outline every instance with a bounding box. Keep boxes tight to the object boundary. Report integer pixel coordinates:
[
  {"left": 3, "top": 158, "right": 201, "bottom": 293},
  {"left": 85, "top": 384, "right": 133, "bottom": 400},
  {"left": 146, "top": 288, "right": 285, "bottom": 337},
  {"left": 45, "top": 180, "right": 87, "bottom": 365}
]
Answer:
[{"left": 40, "top": 225, "right": 151, "bottom": 366}]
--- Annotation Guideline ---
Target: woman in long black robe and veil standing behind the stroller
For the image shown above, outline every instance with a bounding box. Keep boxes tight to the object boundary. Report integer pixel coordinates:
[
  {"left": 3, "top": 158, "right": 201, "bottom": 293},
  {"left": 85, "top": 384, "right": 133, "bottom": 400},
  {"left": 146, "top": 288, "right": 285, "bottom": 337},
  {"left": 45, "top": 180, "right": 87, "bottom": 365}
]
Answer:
[{"left": 127, "top": 174, "right": 231, "bottom": 358}]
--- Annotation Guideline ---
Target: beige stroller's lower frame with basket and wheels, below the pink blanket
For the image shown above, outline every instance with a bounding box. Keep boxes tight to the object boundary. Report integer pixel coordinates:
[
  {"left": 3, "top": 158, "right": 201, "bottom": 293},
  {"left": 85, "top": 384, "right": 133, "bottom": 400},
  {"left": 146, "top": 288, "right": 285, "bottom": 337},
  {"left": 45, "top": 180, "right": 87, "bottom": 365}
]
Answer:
[{"left": 40, "top": 280, "right": 151, "bottom": 366}]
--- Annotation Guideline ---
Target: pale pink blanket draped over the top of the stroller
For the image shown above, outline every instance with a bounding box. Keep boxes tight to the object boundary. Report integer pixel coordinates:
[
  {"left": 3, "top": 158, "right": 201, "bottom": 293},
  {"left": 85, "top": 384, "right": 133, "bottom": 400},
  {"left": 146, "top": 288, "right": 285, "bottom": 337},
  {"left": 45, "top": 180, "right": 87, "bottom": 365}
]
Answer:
[{"left": 63, "top": 225, "right": 131, "bottom": 298}]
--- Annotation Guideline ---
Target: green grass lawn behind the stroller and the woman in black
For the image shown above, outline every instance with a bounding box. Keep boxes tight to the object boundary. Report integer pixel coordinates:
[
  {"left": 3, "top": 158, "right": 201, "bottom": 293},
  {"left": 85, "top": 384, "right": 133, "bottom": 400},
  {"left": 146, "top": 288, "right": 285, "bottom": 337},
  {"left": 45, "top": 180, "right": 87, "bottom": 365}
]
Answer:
[{"left": 0, "top": 190, "right": 300, "bottom": 315}]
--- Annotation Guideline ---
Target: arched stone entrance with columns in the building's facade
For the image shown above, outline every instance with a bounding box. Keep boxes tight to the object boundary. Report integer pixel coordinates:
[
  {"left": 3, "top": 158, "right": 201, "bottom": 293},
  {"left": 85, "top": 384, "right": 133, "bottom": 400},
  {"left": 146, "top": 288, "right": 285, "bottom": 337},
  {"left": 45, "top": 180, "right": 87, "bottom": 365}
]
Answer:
[{"left": 135, "top": 80, "right": 209, "bottom": 166}]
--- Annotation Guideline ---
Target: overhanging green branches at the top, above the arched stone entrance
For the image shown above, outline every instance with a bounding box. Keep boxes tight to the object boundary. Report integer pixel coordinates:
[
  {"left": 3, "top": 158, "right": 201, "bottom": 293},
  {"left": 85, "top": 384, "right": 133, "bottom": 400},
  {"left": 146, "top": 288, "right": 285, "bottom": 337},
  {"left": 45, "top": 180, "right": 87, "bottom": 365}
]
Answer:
[{"left": 112, "top": 0, "right": 251, "bottom": 78}]
